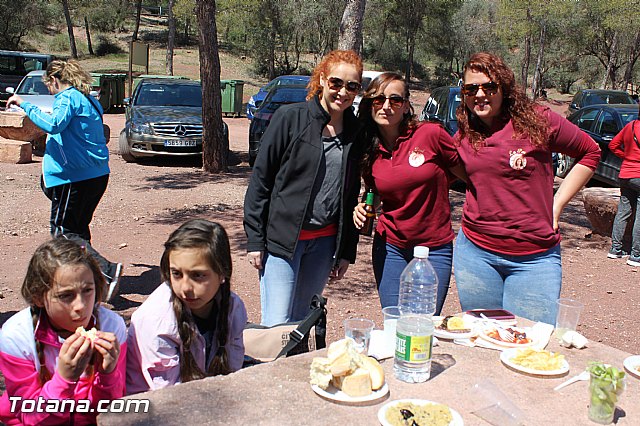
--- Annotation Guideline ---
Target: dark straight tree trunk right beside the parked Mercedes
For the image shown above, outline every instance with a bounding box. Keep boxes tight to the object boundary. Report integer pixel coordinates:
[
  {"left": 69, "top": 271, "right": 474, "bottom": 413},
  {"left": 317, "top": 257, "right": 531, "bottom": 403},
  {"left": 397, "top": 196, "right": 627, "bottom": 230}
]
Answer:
[{"left": 196, "top": 0, "right": 229, "bottom": 173}]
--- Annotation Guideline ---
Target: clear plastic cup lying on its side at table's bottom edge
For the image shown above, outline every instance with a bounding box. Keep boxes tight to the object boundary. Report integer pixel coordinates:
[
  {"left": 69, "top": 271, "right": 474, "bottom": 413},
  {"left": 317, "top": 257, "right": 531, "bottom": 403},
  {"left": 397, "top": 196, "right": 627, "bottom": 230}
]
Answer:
[{"left": 469, "top": 380, "right": 524, "bottom": 426}]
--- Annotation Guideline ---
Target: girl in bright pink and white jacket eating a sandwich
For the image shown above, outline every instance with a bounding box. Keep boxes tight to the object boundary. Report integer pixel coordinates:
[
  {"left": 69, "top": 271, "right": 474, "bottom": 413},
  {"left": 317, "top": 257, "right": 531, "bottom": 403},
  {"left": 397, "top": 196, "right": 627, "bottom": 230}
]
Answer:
[{"left": 0, "top": 237, "right": 126, "bottom": 425}]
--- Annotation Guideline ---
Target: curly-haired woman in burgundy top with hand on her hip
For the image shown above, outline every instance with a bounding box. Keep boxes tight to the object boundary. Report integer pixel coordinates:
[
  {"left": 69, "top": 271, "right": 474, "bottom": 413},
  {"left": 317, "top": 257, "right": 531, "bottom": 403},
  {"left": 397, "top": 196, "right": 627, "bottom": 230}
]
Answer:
[{"left": 453, "top": 53, "right": 600, "bottom": 324}]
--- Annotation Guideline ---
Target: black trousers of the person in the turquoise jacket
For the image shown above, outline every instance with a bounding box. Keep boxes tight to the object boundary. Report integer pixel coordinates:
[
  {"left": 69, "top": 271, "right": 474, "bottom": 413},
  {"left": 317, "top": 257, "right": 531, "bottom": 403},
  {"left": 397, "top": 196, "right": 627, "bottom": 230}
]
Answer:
[{"left": 40, "top": 175, "right": 117, "bottom": 282}]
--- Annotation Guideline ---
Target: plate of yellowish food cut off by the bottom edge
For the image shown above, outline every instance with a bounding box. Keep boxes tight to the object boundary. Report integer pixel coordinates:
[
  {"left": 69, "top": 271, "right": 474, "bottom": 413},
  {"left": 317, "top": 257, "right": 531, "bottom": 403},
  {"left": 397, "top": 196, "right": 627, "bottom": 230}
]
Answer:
[{"left": 378, "top": 399, "right": 464, "bottom": 426}]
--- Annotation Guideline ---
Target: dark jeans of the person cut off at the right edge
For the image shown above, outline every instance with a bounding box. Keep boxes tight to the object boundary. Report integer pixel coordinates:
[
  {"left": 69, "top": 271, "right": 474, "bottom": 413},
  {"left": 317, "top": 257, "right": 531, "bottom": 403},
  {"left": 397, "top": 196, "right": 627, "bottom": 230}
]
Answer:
[{"left": 611, "top": 178, "right": 640, "bottom": 260}]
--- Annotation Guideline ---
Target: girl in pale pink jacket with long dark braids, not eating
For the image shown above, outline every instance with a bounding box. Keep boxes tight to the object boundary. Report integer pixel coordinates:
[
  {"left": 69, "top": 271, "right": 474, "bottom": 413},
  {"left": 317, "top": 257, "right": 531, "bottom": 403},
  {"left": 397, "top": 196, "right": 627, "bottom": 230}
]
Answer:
[{"left": 127, "top": 219, "right": 247, "bottom": 394}]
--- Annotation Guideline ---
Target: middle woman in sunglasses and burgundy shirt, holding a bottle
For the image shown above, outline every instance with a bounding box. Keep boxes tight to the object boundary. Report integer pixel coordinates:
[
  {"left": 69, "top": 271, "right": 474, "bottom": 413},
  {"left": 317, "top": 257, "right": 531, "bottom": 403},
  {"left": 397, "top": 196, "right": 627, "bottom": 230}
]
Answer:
[{"left": 353, "top": 72, "right": 464, "bottom": 315}]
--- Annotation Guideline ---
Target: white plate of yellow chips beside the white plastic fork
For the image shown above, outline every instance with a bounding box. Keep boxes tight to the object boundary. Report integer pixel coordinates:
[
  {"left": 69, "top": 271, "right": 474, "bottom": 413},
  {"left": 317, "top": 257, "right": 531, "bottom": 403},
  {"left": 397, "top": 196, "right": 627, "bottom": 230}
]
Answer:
[{"left": 500, "top": 348, "right": 569, "bottom": 376}]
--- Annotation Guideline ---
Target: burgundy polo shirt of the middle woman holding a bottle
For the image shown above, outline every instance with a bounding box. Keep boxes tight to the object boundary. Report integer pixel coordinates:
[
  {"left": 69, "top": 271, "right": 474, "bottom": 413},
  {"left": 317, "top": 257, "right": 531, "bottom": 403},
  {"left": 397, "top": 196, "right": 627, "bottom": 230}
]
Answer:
[{"left": 372, "top": 123, "right": 460, "bottom": 248}]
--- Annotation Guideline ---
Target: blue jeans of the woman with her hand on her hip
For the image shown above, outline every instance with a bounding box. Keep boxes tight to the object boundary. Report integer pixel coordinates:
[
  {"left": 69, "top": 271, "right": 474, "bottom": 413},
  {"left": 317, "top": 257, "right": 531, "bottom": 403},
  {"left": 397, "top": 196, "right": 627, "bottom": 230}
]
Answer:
[{"left": 453, "top": 228, "right": 562, "bottom": 324}]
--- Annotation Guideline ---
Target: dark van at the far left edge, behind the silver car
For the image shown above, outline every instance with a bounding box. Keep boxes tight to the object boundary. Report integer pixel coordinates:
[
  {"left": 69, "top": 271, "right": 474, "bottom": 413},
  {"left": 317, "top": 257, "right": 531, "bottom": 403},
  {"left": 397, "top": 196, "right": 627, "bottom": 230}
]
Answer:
[{"left": 0, "top": 50, "right": 54, "bottom": 106}]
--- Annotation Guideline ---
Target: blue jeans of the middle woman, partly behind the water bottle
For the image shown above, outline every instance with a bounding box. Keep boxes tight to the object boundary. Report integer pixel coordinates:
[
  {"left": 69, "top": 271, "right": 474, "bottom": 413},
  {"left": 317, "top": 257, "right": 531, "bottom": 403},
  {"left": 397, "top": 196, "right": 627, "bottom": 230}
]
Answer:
[{"left": 372, "top": 234, "right": 453, "bottom": 315}]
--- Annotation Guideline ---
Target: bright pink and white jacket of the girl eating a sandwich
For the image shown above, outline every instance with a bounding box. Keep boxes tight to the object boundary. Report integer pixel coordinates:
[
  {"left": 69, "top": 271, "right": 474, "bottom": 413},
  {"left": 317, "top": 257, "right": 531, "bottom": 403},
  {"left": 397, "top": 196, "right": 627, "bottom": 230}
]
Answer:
[{"left": 0, "top": 306, "right": 127, "bottom": 425}]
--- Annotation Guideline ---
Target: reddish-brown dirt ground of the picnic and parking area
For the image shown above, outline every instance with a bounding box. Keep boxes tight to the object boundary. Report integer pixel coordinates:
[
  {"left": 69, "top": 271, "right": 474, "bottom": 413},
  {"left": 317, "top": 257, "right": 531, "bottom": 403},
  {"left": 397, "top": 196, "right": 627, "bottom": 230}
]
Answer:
[{"left": 0, "top": 97, "right": 640, "bottom": 360}]
